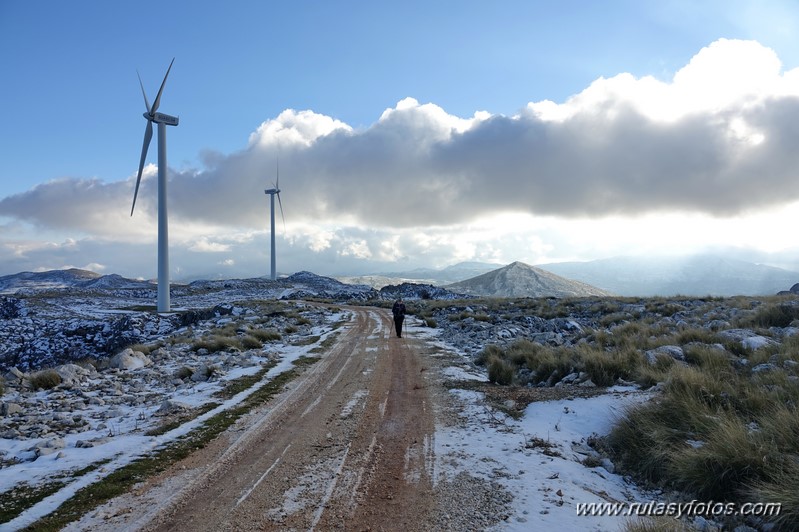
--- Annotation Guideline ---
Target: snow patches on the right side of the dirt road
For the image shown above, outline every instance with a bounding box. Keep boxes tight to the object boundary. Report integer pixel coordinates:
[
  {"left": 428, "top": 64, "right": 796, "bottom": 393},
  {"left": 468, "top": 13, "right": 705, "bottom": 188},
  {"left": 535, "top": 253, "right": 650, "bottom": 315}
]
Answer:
[{"left": 418, "top": 328, "right": 655, "bottom": 531}]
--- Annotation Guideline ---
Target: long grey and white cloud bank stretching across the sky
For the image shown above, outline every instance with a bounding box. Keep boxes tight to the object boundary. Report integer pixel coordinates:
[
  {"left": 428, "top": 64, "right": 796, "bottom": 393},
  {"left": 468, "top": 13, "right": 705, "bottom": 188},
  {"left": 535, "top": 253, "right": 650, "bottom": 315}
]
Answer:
[{"left": 0, "top": 39, "right": 799, "bottom": 276}]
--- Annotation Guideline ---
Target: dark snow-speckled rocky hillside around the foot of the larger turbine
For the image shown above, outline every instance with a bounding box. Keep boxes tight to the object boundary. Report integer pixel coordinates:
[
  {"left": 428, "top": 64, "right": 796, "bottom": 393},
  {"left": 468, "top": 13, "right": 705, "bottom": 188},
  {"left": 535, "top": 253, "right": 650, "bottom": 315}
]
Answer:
[{"left": 0, "top": 270, "right": 462, "bottom": 372}]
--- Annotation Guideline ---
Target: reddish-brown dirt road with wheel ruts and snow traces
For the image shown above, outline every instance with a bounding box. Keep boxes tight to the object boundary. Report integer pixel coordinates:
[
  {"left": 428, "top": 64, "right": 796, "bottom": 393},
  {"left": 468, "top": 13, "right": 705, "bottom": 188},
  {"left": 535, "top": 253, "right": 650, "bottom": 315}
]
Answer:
[{"left": 129, "top": 308, "right": 444, "bottom": 531}]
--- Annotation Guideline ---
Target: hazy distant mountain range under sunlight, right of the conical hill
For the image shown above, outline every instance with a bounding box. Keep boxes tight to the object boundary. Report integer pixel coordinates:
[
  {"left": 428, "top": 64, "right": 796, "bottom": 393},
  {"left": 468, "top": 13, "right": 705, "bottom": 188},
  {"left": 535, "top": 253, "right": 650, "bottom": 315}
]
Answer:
[{"left": 538, "top": 254, "right": 799, "bottom": 296}]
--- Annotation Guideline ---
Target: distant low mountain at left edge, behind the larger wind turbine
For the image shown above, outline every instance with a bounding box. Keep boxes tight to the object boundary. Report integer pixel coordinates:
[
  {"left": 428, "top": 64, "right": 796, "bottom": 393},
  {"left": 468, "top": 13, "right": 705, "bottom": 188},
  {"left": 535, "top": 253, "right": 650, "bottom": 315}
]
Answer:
[{"left": 0, "top": 268, "right": 153, "bottom": 294}]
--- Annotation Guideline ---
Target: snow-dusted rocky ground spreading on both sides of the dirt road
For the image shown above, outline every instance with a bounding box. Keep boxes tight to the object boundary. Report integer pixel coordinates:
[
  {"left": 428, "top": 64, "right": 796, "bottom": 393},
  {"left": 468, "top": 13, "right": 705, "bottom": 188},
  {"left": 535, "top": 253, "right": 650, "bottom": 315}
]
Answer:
[{"left": 0, "top": 276, "right": 799, "bottom": 522}]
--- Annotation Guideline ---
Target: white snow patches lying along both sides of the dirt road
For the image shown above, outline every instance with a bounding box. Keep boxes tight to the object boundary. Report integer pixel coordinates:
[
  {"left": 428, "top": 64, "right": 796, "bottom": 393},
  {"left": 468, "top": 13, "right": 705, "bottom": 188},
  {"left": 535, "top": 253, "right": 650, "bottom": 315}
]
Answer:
[{"left": 0, "top": 315, "right": 653, "bottom": 531}]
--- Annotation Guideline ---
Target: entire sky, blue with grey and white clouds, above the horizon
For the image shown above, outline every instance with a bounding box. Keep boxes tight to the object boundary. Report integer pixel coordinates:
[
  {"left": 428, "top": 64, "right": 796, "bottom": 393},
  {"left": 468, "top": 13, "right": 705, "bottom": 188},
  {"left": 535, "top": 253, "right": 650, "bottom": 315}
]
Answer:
[{"left": 0, "top": 0, "right": 799, "bottom": 278}]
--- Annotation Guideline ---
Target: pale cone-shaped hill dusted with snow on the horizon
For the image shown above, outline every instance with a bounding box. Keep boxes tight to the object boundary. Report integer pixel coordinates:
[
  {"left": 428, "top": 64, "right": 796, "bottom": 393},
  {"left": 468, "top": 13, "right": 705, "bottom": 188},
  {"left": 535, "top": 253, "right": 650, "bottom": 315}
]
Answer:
[{"left": 444, "top": 262, "right": 611, "bottom": 297}]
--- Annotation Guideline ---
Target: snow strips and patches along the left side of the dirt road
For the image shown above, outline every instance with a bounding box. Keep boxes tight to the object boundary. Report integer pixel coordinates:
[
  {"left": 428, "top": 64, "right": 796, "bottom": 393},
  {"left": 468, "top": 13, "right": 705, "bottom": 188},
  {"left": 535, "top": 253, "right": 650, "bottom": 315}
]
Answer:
[{"left": 0, "top": 312, "right": 348, "bottom": 532}]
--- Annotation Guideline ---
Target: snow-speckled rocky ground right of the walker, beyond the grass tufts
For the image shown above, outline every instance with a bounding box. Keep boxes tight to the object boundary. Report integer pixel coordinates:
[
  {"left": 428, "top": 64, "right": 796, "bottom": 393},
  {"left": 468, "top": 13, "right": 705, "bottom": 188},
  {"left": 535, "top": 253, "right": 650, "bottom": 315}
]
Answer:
[{"left": 419, "top": 296, "right": 799, "bottom": 380}]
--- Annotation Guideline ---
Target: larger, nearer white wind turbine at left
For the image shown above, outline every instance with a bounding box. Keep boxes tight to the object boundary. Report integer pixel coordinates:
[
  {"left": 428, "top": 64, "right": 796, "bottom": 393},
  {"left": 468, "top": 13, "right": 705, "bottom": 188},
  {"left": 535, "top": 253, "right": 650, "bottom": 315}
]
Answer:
[{"left": 130, "top": 57, "right": 178, "bottom": 312}]
